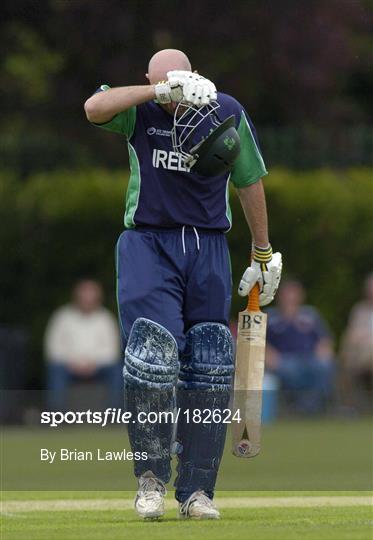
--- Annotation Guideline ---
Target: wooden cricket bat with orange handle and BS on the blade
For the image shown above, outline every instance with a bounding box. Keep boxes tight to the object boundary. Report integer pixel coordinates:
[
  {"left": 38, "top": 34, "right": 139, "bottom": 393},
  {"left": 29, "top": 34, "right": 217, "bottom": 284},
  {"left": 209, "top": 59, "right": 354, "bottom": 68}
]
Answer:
[{"left": 232, "top": 284, "right": 267, "bottom": 458}]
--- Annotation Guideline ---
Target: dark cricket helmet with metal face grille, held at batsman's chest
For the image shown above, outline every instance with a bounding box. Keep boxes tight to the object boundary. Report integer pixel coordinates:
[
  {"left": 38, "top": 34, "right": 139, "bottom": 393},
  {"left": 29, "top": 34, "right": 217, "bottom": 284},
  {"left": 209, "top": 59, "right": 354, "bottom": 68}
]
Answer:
[{"left": 171, "top": 101, "right": 240, "bottom": 176}]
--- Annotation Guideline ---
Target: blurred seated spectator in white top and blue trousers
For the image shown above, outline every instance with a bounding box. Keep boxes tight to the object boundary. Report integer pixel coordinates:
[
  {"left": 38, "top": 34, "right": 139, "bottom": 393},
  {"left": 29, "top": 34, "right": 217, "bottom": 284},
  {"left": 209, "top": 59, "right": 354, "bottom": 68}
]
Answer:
[{"left": 44, "top": 280, "right": 123, "bottom": 410}]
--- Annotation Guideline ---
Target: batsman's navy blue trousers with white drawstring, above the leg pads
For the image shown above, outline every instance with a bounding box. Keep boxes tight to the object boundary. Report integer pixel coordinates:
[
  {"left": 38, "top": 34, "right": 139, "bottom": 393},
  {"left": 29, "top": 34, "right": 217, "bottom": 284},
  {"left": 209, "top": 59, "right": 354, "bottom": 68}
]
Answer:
[{"left": 116, "top": 228, "right": 232, "bottom": 352}]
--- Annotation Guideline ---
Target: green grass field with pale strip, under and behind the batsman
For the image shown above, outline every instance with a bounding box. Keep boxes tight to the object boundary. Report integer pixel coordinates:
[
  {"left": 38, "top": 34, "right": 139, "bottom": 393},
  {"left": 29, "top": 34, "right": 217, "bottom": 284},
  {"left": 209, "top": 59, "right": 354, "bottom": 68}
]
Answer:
[{"left": 1, "top": 419, "right": 373, "bottom": 540}]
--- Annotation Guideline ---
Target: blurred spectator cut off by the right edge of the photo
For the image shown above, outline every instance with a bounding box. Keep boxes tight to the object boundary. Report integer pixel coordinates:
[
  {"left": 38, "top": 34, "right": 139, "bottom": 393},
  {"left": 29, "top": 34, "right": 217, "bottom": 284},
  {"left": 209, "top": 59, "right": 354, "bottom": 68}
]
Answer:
[{"left": 340, "top": 272, "right": 373, "bottom": 408}]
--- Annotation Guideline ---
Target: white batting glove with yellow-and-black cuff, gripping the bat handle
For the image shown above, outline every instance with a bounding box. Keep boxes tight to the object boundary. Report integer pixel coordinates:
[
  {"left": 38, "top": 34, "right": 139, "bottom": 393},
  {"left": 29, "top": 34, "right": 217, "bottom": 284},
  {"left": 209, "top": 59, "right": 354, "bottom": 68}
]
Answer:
[{"left": 238, "top": 245, "right": 282, "bottom": 306}]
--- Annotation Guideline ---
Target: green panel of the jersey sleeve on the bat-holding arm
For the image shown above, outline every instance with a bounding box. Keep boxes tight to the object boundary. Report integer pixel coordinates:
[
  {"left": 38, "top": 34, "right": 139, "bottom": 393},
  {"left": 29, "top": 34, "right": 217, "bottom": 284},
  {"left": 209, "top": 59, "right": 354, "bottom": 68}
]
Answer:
[{"left": 230, "top": 111, "right": 268, "bottom": 188}]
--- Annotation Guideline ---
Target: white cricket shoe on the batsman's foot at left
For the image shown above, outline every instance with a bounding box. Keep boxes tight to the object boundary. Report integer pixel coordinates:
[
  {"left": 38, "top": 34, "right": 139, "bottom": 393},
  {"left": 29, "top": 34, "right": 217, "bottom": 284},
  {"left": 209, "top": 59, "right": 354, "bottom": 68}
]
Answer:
[{"left": 135, "top": 471, "right": 167, "bottom": 519}]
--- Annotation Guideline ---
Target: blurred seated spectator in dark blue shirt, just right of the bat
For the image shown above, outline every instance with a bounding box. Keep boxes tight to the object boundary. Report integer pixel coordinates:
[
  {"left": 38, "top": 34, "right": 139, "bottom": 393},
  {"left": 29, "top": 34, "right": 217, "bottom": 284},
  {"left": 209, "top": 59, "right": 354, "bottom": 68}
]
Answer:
[{"left": 266, "top": 280, "right": 334, "bottom": 414}]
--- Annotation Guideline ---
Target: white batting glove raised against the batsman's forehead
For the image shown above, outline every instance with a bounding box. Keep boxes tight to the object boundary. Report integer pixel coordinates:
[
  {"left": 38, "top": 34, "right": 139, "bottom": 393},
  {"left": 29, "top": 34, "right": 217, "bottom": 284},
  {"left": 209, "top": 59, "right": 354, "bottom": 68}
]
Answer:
[{"left": 167, "top": 70, "right": 217, "bottom": 107}]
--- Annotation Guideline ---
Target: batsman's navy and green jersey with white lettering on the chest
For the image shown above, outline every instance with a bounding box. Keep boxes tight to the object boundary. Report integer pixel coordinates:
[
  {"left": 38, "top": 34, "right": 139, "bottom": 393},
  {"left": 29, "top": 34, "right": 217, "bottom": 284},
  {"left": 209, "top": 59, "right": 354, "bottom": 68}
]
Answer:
[{"left": 93, "top": 85, "right": 267, "bottom": 231}]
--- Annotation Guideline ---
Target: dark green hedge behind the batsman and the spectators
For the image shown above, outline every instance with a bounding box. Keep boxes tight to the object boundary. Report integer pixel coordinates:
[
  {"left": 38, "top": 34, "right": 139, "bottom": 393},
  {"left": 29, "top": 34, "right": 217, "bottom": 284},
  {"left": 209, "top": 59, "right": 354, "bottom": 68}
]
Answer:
[{"left": 0, "top": 169, "right": 373, "bottom": 384}]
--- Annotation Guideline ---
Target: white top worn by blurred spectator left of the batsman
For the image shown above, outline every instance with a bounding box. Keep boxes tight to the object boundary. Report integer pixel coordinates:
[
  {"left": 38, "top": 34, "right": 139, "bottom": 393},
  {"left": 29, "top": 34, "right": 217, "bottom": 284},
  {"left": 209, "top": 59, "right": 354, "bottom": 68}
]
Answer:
[{"left": 44, "top": 305, "right": 120, "bottom": 367}]
